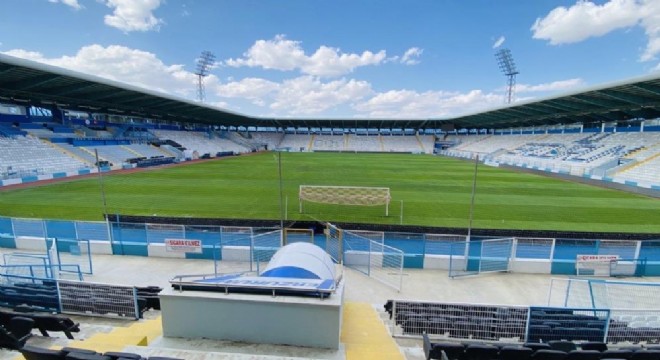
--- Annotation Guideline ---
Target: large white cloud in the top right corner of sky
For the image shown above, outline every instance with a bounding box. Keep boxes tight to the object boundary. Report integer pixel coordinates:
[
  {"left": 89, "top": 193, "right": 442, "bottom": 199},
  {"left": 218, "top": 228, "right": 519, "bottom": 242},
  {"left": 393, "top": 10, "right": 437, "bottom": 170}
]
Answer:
[{"left": 531, "top": 0, "right": 660, "bottom": 61}]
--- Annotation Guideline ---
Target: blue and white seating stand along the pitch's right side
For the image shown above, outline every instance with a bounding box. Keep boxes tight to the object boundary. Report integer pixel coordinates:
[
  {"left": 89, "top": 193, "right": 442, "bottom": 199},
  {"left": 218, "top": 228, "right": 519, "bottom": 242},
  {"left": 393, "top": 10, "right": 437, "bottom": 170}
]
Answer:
[{"left": 440, "top": 132, "right": 660, "bottom": 187}]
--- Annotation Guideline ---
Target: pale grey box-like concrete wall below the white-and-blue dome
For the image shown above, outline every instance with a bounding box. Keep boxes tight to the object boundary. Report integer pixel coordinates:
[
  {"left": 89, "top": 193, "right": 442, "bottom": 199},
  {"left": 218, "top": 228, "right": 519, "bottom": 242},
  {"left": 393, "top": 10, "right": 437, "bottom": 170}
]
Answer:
[{"left": 160, "top": 283, "right": 343, "bottom": 349}]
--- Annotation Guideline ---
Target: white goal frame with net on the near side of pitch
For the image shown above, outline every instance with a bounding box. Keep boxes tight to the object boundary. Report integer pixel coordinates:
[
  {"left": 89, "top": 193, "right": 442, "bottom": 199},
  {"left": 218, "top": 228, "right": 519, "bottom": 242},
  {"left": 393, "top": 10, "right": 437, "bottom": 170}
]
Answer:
[{"left": 298, "top": 185, "right": 392, "bottom": 216}]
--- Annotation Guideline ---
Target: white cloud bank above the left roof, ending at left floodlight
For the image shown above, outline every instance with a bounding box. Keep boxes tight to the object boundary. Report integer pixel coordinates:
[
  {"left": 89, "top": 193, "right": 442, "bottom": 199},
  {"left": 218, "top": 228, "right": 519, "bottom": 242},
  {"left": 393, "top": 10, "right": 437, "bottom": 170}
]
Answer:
[{"left": 5, "top": 44, "right": 200, "bottom": 98}]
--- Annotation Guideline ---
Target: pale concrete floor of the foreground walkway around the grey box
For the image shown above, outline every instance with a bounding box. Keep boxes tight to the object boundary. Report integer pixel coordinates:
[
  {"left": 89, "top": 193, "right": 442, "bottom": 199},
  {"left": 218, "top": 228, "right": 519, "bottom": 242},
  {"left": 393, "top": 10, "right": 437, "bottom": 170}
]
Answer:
[{"left": 0, "top": 249, "right": 624, "bottom": 360}]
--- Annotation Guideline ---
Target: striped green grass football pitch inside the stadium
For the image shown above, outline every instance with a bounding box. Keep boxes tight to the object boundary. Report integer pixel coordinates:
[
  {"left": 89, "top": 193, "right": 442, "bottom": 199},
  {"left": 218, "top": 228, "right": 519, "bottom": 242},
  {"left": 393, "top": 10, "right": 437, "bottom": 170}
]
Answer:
[{"left": 0, "top": 153, "right": 660, "bottom": 234}]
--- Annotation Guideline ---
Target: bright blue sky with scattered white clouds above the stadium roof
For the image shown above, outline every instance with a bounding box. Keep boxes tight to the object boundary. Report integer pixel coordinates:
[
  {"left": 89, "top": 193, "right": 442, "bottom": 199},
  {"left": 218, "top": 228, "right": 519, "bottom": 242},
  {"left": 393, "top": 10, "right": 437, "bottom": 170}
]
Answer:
[{"left": 0, "top": 0, "right": 660, "bottom": 118}]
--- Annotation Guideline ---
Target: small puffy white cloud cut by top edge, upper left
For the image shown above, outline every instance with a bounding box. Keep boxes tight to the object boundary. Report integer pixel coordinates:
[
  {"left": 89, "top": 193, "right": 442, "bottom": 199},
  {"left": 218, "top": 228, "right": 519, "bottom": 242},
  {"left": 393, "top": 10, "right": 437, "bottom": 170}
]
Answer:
[{"left": 104, "top": 0, "right": 163, "bottom": 32}]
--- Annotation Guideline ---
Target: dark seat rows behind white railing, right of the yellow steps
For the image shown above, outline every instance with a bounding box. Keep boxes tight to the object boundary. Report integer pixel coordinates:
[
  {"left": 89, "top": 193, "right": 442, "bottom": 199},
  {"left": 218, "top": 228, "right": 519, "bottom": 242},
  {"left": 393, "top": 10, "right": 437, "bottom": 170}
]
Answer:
[{"left": 385, "top": 301, "right": 660, "bottom": 344}]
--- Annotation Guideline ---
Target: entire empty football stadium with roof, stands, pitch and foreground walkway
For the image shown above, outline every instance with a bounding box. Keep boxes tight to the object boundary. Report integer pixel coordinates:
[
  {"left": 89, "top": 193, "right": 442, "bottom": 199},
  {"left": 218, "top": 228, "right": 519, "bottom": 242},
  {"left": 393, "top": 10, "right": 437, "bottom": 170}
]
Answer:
[{"left": 0, "top": 31, "right": 660, "bottom": 360}]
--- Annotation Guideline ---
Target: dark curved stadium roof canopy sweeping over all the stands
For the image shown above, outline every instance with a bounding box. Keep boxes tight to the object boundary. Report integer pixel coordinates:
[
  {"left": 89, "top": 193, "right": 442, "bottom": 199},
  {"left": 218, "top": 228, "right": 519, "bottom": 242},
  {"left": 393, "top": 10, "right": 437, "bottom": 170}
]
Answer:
[{"left": 0, "top": 54, "right": 660, "bottom": 129}]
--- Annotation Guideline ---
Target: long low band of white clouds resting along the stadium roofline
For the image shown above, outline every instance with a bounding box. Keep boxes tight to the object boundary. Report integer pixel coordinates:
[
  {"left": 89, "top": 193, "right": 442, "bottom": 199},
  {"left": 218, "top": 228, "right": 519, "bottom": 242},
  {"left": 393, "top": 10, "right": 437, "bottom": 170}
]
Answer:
[{"left": 0, "top": 45, "right": 583, "bottom": 118}]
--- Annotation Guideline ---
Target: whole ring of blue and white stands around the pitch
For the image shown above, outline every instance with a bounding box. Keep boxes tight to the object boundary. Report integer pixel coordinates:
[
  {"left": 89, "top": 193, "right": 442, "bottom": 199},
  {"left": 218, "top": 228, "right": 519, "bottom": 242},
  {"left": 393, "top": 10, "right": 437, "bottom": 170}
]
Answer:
[{"left": 3, "top": 119, "right": 660, "bottom": 188}]
